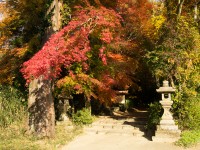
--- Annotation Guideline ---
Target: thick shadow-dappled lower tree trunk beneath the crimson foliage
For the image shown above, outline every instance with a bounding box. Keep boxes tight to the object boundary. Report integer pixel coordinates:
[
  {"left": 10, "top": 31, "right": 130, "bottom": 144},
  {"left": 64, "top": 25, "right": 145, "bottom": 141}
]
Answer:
[{"left": 28, "top": 77, "right": 55, "bottom": 137}]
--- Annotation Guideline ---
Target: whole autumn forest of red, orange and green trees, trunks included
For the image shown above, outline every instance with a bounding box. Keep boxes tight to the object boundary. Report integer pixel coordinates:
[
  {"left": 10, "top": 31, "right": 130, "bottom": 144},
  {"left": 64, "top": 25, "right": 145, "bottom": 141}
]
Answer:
[{"left": 0, "top": 0, "right": 200, "bottom": 148}]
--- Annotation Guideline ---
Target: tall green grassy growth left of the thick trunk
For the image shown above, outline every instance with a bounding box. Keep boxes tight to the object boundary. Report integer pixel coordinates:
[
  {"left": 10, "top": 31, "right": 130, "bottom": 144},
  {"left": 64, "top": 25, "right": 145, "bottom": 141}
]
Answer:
[{"left": 0, "top": 85, "right": 26, "bottom": 128}]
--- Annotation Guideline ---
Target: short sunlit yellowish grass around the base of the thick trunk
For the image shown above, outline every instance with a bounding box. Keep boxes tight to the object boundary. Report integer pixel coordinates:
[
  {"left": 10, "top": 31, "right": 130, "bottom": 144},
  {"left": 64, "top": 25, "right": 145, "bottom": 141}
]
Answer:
[{"left": 0, "top": 119, "right": 82, "bottom": 150}]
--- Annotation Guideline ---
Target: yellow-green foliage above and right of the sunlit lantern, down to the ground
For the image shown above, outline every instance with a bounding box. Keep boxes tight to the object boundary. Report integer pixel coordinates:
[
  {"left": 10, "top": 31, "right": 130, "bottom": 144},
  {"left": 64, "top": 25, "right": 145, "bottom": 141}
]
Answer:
[{"left": 146, "top": 13, "right": 200, "bottom": 129}]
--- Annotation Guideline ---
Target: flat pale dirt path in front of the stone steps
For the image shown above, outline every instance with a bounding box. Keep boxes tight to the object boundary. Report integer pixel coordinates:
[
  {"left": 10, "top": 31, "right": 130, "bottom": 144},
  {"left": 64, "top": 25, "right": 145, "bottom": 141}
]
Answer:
[{"left": 61, "top": 134, "right": 200, "bottom": 150}]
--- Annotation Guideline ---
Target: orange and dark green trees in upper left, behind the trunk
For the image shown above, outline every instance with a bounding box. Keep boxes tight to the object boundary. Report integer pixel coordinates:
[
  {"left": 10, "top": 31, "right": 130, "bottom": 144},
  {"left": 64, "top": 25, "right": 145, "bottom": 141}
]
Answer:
[{"left": 0, "top": 0, "right": 48, "bottom": 86}]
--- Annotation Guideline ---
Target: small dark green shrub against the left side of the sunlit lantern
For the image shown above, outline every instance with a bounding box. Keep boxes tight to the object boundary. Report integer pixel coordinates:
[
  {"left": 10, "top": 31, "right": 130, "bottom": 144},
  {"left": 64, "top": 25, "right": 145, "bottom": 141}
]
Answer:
[{"left": 146, "top": 102, "right": 163, "bottom": 130}]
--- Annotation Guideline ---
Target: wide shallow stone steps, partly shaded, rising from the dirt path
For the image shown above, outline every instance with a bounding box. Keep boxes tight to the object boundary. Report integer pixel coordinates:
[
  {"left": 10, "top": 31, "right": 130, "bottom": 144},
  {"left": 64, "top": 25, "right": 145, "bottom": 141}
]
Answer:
[{"left": 84, "top": 109, "right": 148, "bottom": 136}]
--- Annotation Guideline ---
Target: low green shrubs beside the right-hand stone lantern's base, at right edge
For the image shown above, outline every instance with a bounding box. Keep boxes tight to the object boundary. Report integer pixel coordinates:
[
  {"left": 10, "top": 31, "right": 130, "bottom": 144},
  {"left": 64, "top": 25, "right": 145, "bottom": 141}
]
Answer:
[{"left": 176, "top": 94, "right": 200, "bottom": 147}]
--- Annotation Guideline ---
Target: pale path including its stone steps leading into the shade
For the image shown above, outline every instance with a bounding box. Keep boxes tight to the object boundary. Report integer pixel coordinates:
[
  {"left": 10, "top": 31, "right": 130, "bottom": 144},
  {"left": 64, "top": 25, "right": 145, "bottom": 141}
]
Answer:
[{"left": 61, "top": 110, "right": 200, "bottom": 150}]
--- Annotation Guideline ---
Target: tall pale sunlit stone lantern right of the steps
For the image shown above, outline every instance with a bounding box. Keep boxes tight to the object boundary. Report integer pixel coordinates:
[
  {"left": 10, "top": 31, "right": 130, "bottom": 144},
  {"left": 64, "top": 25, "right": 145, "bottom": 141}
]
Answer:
[{"left": 153, "top": 80, "right": 180, "bottom": 141}]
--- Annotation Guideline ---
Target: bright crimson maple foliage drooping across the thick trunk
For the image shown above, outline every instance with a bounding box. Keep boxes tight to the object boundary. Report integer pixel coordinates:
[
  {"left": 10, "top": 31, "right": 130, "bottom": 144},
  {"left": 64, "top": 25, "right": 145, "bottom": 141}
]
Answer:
[{"left": 21, "top": 6, "right": 120, "bottom": 83}]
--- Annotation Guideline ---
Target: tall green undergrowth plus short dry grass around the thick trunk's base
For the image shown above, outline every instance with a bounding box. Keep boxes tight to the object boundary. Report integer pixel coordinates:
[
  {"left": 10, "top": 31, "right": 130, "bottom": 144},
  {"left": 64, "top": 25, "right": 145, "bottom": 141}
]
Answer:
[{"left": 0, "top": 85, "right": 82, "bottom": 150}]
